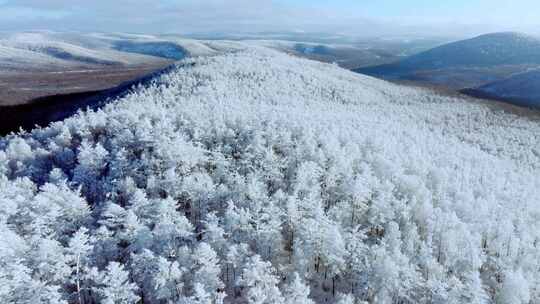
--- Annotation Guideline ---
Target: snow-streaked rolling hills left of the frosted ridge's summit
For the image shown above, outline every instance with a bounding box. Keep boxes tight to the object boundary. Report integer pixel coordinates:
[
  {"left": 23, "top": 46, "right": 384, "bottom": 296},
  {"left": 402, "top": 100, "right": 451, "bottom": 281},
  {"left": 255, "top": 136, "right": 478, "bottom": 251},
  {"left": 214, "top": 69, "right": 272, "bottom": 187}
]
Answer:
[{"left": 0, "top": 32, "right": 228, "bottom": 71}]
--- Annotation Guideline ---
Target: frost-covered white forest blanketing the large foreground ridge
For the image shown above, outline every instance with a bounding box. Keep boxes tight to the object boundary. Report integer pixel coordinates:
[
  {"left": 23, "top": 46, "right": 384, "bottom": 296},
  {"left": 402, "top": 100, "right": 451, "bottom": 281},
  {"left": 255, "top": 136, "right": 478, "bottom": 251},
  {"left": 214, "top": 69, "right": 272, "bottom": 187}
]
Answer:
[{"left": 0, "top": 47, "right": 540, "bottom": 304}]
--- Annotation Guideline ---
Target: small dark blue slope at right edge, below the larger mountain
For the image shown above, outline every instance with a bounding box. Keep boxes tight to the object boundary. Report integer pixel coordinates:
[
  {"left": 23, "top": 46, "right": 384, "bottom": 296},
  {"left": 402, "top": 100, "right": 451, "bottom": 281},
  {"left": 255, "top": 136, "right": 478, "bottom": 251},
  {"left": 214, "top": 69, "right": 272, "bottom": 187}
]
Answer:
[{"left": 462, "top": 69, "right": 540, "bottom": 108}]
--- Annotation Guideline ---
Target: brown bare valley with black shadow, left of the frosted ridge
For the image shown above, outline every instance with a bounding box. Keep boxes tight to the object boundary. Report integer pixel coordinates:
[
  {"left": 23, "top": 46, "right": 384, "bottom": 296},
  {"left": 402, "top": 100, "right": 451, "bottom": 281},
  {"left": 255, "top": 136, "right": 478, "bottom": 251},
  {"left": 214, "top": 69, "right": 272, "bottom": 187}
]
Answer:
[{"left": 0, "top": 62, "right": 172, "bottom": 136}]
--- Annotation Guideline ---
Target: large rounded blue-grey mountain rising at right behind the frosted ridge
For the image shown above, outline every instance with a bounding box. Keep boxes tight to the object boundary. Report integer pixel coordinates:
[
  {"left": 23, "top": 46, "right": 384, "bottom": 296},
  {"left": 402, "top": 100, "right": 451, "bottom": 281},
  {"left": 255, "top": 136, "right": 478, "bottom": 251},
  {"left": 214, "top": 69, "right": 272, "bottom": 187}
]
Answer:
[{"left": 356, "top": 32, "right": 540, "bottom": 88}]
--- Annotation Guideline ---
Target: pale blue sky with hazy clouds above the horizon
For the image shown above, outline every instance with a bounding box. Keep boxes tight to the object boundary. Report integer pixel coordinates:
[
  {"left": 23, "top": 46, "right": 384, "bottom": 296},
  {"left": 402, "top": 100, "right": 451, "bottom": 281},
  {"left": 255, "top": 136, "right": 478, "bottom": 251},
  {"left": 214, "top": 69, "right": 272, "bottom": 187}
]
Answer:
[{"left": 0, "top": 0, "right": 540, "bottom": 36}]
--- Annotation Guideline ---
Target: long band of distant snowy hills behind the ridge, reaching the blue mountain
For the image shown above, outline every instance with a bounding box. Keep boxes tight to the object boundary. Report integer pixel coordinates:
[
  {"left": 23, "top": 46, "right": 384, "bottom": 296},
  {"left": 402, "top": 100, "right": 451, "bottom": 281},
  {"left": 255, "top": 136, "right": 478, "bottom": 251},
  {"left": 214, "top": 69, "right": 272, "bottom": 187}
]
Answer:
[{"left": 0, "top": 31, "right": 440, "bottom": 69}]
